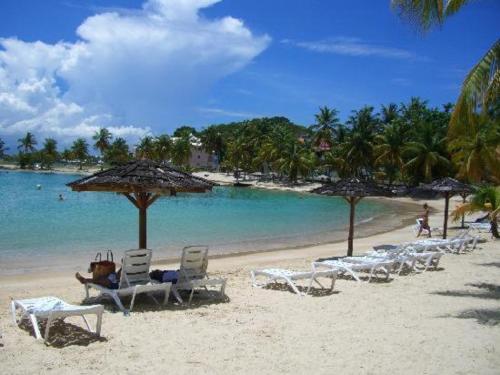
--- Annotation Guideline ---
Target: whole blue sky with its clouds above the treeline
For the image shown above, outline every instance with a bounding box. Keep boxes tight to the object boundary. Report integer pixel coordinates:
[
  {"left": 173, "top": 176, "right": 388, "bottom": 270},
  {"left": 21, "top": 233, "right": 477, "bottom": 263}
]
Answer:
[{"left": 0, "top": 0, "right": 500, "bottom": 149}]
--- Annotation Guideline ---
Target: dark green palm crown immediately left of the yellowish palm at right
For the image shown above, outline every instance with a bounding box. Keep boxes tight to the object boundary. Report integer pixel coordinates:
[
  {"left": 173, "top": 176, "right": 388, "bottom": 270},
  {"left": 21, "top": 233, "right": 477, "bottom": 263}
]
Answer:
[{"left": 403, "top": 123, "right": 450, "bottom": 182}]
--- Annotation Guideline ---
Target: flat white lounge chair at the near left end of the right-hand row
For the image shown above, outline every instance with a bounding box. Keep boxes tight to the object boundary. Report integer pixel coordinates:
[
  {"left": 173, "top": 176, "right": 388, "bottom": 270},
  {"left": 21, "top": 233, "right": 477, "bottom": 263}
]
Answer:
[{"left": 250, "top": 268, "right": 338, "bottom": 296}]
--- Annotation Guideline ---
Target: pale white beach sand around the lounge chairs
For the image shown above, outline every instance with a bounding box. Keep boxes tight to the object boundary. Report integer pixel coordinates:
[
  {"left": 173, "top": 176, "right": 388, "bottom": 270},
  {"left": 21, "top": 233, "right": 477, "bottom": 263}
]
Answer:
[{"left": 0, "top": 198, "right": 500, "bottom": 375}]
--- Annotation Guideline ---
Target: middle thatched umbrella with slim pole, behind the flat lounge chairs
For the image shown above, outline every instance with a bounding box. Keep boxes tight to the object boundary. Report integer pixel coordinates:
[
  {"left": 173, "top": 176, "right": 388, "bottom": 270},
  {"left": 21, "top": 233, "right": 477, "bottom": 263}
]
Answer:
[{"left": 312, "top": 178, "right": 392, "bottom": 256}]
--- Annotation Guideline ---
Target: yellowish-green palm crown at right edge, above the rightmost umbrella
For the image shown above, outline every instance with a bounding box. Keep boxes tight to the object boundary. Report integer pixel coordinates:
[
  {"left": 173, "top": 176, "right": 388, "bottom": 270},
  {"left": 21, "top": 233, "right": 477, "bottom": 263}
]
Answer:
[{"left": 448, "top": 115, "right": 500, "bottom": 183}]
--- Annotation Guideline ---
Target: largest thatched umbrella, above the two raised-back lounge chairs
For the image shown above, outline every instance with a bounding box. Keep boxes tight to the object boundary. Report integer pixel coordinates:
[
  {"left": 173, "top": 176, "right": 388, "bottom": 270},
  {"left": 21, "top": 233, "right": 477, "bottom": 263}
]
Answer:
[{"left": 67, "top": 160, "right": 214, "bottom": 249}]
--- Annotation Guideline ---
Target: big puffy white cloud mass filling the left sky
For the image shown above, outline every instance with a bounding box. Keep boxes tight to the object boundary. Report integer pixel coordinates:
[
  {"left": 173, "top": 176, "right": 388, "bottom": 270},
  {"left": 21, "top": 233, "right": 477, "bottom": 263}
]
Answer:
[{"left": 0, "top": 0, "right": 270, "bottom": 147}]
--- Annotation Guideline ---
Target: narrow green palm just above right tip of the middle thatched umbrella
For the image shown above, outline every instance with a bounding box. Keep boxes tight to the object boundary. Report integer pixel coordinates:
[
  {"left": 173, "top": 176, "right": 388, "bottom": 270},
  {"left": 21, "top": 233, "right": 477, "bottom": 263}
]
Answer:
[{"left": 374, "top": 122, "right": 406, "bottom": 184}]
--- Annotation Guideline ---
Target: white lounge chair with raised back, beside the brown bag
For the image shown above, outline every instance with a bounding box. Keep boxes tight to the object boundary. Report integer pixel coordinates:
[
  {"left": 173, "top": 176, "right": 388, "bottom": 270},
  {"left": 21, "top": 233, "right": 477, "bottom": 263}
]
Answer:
[{"left": 85, "top": 249, "right": 172, "bottom": 314}]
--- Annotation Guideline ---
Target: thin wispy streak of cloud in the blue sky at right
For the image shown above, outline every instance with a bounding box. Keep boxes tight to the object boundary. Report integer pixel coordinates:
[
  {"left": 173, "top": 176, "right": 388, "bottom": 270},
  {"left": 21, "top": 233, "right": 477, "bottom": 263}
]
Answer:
[{"left": 281, "top": 37, "right": 426, "bottom": 60}]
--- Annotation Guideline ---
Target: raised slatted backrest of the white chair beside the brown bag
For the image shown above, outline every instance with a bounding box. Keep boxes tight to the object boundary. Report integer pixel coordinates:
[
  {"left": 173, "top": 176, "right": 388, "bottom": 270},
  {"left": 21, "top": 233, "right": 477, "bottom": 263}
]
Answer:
[{"left": 119, "top": 249, "right": 153, "bottom": 288}]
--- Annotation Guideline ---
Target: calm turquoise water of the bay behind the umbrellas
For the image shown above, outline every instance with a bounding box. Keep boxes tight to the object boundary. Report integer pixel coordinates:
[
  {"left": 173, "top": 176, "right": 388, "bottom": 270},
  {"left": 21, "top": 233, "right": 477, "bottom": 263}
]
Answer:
[{"left": 0, "top": 172, "right": 389, "bottom": 272}]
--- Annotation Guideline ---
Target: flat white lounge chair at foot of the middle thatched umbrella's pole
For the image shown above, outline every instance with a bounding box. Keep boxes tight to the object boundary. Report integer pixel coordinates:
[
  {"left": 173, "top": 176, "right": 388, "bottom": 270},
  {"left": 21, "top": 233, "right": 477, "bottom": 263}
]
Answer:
[{"left": 312, "top": 257, "right": 394, "bottom": 282}]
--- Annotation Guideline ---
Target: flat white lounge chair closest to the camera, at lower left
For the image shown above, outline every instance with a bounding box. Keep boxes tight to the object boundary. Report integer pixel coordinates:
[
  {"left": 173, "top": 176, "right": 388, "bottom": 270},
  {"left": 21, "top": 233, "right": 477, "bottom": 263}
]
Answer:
[{"left": 11, "top": 297, "right": 104, "bottom": 341}]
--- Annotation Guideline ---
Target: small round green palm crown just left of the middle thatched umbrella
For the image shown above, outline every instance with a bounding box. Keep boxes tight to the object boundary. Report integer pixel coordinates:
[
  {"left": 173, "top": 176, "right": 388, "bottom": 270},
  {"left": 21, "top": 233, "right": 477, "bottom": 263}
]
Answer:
[{"left": 278, "top": 142, "right": 316, "bottom": 184}]
